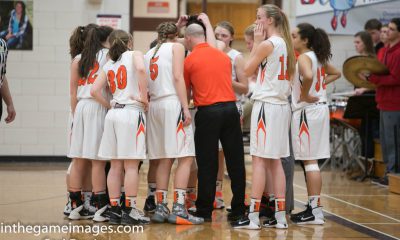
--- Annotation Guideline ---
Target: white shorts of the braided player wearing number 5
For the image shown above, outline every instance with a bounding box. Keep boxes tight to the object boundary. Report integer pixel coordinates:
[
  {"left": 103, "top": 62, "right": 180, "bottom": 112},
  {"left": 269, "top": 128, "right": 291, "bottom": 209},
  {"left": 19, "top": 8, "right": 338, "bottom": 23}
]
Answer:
[{"left": 147, "top": 96, "right": 195, "bottom": 160}]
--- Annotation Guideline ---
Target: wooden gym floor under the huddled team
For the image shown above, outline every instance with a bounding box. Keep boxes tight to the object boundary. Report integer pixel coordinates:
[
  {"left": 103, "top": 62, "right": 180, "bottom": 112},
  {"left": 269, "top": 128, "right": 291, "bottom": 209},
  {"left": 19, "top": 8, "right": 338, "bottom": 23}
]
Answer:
[{"left": 0, "top": 156, "right": 400, "bottom": 240}]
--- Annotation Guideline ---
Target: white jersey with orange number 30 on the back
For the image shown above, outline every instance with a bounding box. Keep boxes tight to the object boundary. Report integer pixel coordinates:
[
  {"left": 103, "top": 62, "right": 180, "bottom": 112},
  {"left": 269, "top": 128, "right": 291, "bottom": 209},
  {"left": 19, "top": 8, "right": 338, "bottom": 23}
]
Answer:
[{"left": 103, "top": 51, "right": 141, "bottom": 106}]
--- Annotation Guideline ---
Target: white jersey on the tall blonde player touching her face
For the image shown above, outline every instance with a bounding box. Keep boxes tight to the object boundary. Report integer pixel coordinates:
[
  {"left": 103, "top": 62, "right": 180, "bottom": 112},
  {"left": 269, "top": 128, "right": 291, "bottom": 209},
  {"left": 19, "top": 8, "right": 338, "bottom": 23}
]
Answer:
[{"left": 251, "top": 36, "right": 290, "bottom": 104}]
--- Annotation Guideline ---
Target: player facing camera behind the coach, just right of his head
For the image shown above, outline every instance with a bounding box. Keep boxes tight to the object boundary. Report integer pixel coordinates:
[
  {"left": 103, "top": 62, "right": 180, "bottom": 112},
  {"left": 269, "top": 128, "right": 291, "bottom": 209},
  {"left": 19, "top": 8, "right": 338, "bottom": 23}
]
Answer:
[{"left": 214, "top": 21, "right": 248, "bottom": 209}]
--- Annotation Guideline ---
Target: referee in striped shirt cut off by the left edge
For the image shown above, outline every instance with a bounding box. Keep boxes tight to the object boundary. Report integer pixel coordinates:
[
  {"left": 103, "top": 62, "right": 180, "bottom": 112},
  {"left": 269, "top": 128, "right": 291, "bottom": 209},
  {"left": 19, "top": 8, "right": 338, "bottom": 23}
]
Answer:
[{"left": 0, "top": 38, "right": 15, "bottom": 123}]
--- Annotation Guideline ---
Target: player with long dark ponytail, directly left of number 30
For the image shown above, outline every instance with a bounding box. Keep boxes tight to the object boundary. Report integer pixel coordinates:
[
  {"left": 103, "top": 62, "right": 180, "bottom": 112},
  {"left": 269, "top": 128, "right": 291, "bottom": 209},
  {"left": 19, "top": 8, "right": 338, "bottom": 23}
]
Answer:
[{"left": 68, "top": 26, "right": 112, "bottom": 221}]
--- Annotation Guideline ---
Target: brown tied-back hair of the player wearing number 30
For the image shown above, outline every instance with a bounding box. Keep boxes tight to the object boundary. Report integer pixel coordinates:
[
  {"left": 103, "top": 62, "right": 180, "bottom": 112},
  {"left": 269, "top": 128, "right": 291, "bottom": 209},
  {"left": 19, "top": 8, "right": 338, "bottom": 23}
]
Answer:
[{"left": 108, "top": 30, "right": 132, "bottom": 62}]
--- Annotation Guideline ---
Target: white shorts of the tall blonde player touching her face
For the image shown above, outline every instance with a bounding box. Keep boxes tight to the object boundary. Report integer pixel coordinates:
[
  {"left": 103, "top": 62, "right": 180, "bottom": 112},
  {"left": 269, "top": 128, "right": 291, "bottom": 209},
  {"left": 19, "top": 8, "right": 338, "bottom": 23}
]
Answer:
[{"left": 250, "top": 101, "right": 291, "bottom": 159}]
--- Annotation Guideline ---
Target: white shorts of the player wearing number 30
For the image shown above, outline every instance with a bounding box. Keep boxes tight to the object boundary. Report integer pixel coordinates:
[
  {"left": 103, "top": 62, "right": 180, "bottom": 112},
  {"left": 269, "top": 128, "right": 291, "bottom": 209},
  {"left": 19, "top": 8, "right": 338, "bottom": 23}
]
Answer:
[{"left": 99, "top": 105, "right": 146, "bottom": 160}]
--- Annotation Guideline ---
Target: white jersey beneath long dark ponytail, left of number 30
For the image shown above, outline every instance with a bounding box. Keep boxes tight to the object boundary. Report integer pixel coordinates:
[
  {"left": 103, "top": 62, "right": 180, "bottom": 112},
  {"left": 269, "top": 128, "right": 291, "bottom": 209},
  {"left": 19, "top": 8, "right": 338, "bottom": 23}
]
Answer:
[{"left": 75, "top": 48, "right": 108, "bottom": 100}]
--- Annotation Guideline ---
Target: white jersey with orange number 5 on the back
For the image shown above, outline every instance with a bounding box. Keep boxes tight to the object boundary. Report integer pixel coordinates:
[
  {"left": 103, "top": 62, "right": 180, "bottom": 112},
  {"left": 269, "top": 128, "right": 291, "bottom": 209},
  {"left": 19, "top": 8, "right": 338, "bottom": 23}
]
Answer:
[{"left": 144, "top": 43, "right": 176, "bottom": 100}]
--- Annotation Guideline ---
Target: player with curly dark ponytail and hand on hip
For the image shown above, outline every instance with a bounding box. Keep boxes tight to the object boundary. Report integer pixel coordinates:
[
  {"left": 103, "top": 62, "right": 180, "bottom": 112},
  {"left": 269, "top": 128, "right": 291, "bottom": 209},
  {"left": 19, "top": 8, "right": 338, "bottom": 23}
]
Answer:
[{"left": 291, "top": 23, "right": 341, "bottom": 224}]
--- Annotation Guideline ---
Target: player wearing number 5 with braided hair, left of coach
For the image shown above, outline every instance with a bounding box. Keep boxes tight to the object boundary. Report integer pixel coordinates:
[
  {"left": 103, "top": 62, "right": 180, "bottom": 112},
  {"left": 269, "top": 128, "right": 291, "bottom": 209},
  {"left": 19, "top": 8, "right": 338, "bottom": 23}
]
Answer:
[{"left": 145, "top": 22, "right": 204, "bottom": 224}]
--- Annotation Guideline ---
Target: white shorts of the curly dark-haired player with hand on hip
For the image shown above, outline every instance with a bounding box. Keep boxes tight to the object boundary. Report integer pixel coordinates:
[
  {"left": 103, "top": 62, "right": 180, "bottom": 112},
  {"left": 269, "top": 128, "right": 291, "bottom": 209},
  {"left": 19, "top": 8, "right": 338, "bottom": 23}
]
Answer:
[{"left": 292, "top": 105, "right": 330, "bottom": 160}]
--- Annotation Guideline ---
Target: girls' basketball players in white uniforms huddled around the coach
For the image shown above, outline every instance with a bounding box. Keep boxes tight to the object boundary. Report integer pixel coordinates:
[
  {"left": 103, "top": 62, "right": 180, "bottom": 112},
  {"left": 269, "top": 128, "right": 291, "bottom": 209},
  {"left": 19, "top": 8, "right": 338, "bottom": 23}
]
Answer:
[{"left": 64, "top": 2, "right": 340, "bottom": 229}]
